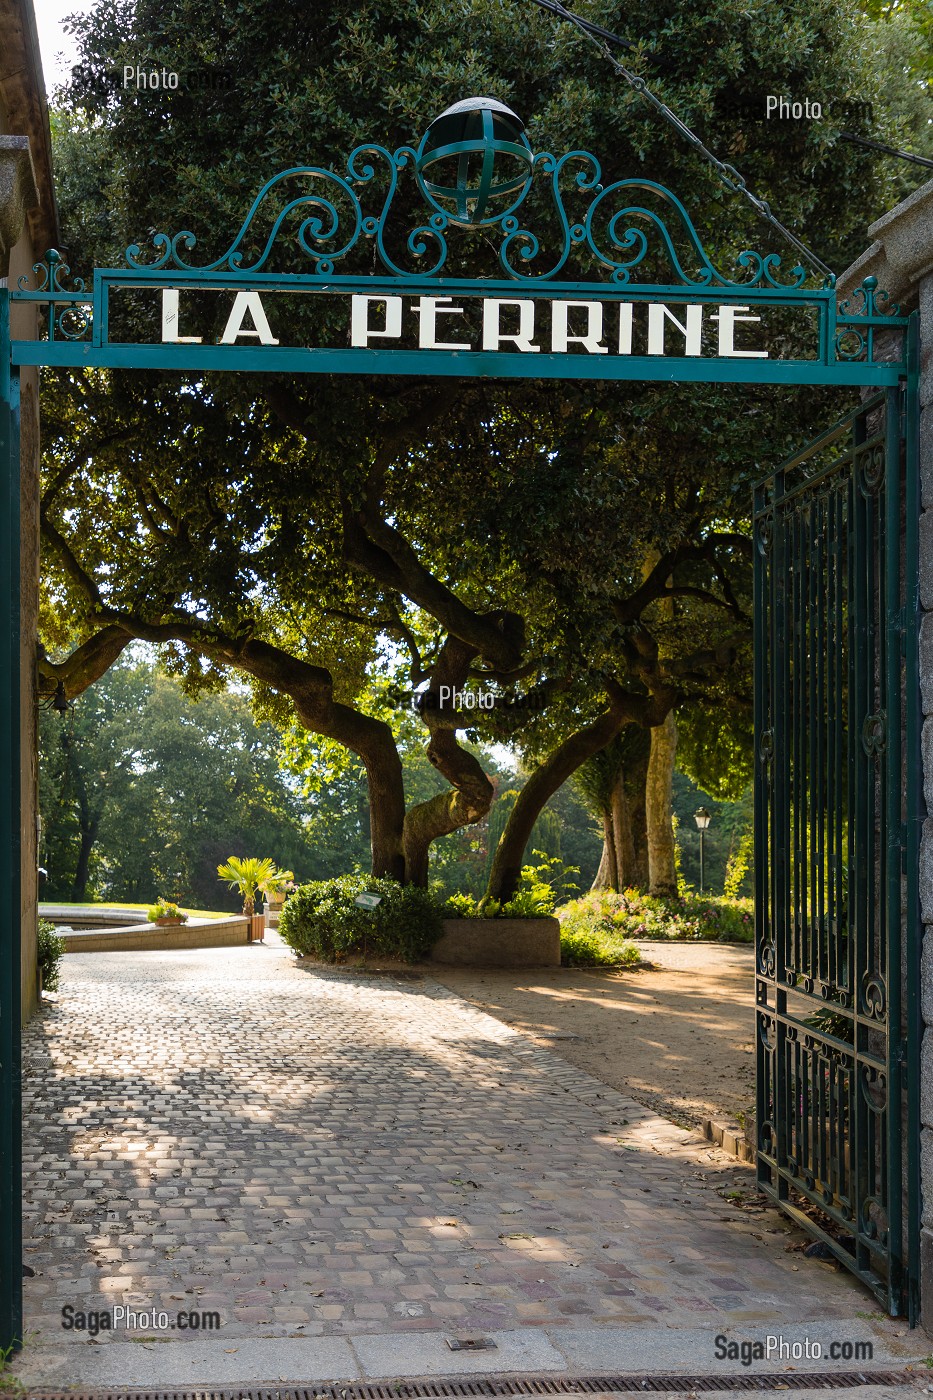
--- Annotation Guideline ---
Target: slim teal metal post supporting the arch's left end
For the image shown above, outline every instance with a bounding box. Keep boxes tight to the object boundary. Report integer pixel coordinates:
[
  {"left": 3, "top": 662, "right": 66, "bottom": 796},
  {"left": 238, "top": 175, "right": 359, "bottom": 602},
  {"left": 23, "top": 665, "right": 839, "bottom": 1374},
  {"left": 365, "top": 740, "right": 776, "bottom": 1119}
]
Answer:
[{"left": 0, "top": 287, "right": 22, "bottom": 1348}]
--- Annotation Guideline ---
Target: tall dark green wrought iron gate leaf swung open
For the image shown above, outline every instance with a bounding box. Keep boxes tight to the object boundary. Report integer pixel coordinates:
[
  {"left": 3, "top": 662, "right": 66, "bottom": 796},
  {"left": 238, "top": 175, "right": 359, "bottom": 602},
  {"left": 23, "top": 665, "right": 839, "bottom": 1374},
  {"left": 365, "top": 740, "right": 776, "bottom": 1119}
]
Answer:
[{"left": 754, "top": 361, "right": 919, "bottom": 1320}]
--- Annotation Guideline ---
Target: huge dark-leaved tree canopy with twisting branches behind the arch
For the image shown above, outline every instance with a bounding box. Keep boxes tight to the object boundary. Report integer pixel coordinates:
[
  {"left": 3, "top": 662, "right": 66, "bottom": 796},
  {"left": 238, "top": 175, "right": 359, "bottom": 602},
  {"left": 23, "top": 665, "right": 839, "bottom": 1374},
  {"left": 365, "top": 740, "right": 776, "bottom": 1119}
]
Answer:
[{"left": 42, "top": 0, "right": 913, "bottom": 893}]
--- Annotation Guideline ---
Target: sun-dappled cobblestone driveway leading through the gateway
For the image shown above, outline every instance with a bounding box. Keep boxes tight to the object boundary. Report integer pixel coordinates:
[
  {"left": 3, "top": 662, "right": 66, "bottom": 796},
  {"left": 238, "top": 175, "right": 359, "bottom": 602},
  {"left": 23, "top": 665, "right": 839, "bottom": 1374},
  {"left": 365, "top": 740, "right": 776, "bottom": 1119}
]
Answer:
[{"left": 25, "top": 946, "right": 874, "bottom": 1345}]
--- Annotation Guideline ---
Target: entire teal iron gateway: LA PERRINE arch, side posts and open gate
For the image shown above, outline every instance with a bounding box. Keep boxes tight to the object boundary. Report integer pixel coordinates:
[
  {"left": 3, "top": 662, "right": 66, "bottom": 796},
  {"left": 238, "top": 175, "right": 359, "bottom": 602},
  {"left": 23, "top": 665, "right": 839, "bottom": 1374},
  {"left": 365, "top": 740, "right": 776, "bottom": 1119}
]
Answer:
[{"left": 0, "top": 98, "right": 919, "bottom": 1345}]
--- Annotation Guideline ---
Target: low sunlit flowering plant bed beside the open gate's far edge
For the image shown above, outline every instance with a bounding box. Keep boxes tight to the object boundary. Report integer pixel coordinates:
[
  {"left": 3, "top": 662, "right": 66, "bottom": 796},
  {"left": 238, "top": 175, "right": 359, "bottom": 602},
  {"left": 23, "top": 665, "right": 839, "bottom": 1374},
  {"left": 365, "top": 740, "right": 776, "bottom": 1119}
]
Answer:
[{"left": 558, "top": 889, "right": 755, "bottom": 944}]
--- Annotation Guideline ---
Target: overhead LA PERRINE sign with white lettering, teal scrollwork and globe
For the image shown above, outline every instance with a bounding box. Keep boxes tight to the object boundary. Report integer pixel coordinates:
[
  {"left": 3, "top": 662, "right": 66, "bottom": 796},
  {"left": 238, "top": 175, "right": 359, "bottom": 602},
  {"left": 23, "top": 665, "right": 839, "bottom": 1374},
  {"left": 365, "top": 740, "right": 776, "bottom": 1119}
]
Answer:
[{"left": 5, "top": 98, "right": 906, "bottom": 386}]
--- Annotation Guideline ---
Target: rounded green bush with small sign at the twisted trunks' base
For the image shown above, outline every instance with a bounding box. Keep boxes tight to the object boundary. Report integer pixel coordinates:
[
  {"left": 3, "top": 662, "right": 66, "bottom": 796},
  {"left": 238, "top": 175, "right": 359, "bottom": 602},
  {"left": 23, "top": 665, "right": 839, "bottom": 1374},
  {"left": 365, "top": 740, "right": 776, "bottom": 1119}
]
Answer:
[{"left": 279, "top": 875, "right": 441, "bottom": 962}]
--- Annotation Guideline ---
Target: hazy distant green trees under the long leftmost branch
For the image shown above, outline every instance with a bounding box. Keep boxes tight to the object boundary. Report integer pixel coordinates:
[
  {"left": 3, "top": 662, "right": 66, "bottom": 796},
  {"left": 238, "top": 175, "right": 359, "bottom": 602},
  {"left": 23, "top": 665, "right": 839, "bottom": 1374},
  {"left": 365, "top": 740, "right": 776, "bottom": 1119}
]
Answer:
[{"left": 39, "top": 645, "right": 313, "bottom": 910}]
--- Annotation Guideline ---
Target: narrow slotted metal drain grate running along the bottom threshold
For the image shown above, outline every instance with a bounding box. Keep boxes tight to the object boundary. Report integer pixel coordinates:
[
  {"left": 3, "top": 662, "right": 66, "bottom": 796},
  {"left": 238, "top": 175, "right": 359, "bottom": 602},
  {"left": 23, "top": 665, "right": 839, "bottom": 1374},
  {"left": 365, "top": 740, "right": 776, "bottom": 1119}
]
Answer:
[{"left": 22, "top": 1371, "right": 916, "bottom": 1400}]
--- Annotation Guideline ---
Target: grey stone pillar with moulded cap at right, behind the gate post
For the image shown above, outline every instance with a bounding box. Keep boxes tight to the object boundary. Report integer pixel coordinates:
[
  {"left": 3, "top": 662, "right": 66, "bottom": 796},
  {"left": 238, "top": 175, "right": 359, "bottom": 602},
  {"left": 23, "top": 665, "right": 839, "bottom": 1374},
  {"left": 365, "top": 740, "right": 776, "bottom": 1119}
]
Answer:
[{"left": 839, "top": 181, "right": 933, "bottom": 1333}]
